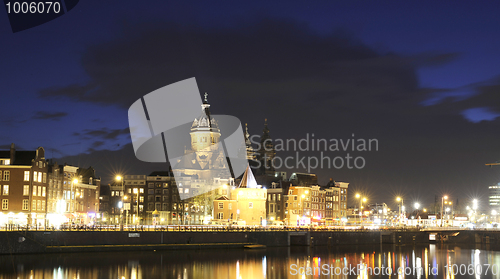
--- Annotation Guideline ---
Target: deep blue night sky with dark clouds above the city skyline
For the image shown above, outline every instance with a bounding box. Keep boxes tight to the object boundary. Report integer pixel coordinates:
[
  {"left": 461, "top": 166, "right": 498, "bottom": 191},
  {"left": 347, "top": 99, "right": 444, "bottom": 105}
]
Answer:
[{"left": 0, "top": 1, "right": 500, "bottom": 209}]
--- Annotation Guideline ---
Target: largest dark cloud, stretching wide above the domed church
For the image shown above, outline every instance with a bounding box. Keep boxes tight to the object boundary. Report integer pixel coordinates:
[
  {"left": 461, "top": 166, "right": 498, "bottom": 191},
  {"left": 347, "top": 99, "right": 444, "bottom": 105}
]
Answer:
[{"left": 39, "top": 17, "right": 455, "bottom": 111}]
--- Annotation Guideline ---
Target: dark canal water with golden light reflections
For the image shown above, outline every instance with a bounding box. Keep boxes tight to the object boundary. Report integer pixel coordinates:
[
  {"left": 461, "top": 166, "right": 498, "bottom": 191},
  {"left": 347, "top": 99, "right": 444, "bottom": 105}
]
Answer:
[{"left": 0, "top": 245, "right": 500, "bottom": 279}]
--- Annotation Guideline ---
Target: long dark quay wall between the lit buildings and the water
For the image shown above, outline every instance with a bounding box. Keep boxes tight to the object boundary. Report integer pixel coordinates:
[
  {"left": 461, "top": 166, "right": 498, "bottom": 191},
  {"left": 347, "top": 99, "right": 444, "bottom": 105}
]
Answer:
[{"left": 0, "top": 226, "right": 500, "bottom": 254}]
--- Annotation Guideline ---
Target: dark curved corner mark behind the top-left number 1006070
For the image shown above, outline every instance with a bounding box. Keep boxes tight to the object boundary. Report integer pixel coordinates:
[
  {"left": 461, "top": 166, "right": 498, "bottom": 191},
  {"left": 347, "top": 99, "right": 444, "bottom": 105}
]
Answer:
[{"left": 4, "top": 0, "right": 79, "bottom": 33}]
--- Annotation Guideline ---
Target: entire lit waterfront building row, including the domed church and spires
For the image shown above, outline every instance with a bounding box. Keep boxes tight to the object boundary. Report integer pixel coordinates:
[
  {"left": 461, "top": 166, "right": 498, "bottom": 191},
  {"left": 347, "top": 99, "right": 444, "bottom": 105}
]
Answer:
[{"left": 0, "top": 95, "right": 348, "bottom": 229}]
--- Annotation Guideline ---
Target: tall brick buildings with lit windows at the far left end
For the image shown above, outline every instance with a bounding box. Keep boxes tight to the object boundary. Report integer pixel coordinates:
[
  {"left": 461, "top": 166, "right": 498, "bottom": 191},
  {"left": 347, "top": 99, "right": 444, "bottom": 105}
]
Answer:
[{"left": 0, "top": 144, "right": 100, "bottom": 226}]
